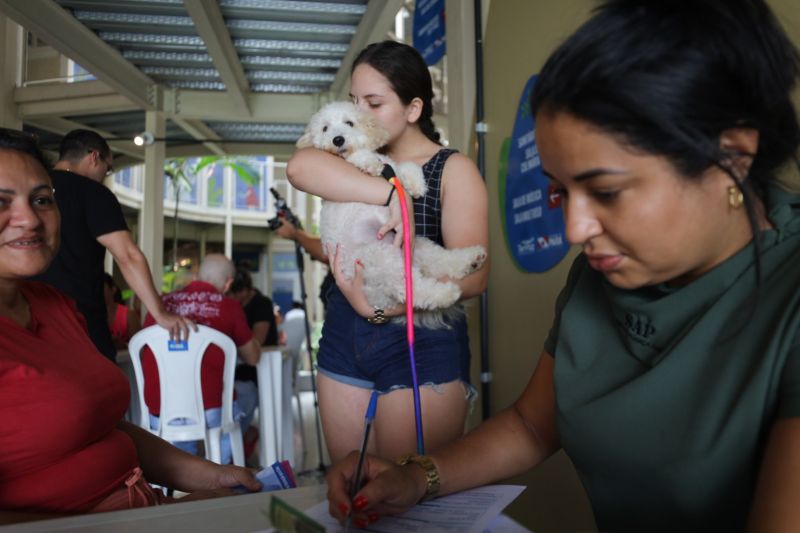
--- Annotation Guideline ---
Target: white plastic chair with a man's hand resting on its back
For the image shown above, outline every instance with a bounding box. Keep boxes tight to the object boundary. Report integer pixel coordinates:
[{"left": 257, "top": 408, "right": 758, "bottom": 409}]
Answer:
[{"left": 128, "top": 325, "right": 244, "bottom": 466}]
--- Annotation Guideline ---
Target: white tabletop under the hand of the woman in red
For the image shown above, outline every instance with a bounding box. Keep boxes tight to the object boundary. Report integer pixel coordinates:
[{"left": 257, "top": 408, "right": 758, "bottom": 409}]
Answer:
[{"left": 0, "top": 485, "right": 326, "bottom": 533}]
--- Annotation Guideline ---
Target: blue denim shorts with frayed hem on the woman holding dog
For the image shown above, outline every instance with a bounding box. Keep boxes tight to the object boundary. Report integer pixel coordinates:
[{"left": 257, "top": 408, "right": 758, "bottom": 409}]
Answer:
[{"left": 317, "top": 286, "right": 471, "bottom": 392}]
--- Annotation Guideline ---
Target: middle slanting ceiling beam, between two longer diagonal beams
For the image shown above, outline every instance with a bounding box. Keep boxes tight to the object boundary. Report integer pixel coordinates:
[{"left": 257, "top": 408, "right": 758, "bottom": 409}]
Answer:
[{"left": 184, "top": 0, "right": 250, "bottom": 113}]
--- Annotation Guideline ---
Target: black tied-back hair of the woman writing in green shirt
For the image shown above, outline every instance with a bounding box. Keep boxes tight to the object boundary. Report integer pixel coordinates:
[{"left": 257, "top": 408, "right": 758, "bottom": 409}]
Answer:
[{"left": 531, "top": 0, "right": 800, "bottom": 280}]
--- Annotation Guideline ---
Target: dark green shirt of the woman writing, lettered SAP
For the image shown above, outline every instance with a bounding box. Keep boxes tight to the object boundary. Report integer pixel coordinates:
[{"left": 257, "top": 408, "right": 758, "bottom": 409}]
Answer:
[{"left": 545, "top": 186, "right": 800, "bottom": 532}]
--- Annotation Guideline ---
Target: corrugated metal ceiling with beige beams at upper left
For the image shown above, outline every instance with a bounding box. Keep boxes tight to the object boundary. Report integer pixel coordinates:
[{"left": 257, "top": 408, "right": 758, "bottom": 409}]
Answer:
[{"left": 0, "top": 0, "right": 404, "bottom": 163}]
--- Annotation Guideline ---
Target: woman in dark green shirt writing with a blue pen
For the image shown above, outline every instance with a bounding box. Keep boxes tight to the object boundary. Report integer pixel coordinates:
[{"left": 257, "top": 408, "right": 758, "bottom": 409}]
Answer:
[{"left": 328, "top": 0, "right": 800, "bottom": 531}]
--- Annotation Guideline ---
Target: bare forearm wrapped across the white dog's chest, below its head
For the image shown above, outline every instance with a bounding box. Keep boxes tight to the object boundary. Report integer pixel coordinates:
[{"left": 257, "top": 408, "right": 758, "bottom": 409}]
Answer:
[{"left": 286, "top": 148, "right": 392, "bottom": 205}]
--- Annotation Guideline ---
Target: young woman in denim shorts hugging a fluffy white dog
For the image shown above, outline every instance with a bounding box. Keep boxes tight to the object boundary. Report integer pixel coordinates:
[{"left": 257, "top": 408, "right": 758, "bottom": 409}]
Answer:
[{"left": 286, "top": 41, "right": 488, "bottom": 461}]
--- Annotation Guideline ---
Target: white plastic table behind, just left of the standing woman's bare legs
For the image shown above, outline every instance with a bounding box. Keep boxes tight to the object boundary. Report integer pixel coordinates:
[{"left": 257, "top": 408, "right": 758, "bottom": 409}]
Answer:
[{"left": 256, "top": 346, "right": 297, "bottom": 469}]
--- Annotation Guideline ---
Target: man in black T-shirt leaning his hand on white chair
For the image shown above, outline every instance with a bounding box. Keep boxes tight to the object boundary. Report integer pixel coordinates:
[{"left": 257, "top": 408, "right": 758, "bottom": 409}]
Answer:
[{"left": 37, "top": 130, "right": 194, "bottom": 361}]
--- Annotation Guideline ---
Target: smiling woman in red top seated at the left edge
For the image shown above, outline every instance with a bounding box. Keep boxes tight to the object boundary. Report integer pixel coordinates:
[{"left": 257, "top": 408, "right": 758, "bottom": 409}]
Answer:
[{"left": 0, "top": 129, "right": 260, "bottom": 524}]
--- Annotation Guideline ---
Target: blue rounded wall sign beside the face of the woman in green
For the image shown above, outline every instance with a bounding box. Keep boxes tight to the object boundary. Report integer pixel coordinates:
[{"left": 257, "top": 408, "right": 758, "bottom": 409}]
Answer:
[{"left": 500, "top": 75, "right": 569, "bottom": 272}]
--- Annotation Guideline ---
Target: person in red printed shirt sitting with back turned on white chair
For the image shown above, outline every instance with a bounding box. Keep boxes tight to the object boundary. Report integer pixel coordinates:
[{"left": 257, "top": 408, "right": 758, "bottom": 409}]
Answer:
[{"left": 142, "top": 254, "right": 261, "bottom": 464}]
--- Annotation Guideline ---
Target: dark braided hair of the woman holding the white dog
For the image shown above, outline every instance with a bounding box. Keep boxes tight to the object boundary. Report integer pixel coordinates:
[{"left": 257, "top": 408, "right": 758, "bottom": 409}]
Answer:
[{"left": 350, "top": 41, "right": 440, "bottom": 144}]
